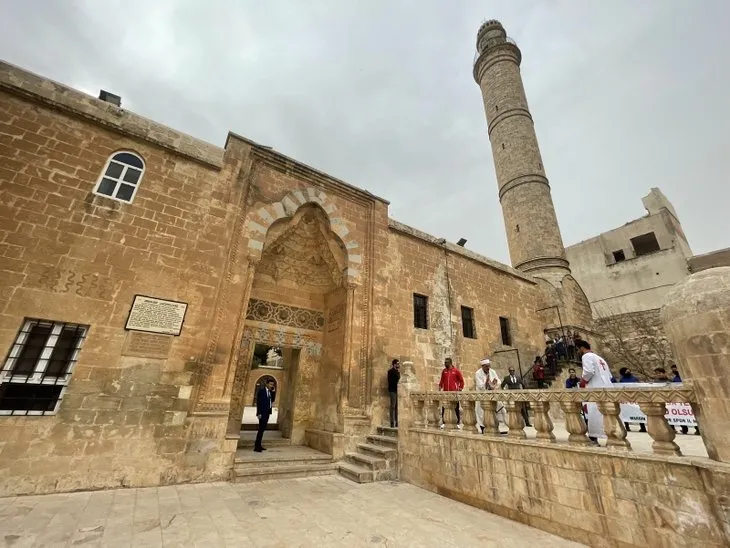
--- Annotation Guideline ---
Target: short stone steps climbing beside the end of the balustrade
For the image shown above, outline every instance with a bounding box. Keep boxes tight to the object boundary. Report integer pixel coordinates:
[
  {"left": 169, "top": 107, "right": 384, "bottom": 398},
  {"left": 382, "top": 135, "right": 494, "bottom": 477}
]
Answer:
[{"left": 338, "top": 426, "right": 398, "bottom": 483}]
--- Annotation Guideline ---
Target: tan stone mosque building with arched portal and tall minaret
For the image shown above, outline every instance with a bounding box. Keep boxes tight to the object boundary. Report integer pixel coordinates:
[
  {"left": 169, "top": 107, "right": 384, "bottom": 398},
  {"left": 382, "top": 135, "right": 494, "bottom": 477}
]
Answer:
[{"left": 0, "top": 21, "right": 595, "bottom": 494}]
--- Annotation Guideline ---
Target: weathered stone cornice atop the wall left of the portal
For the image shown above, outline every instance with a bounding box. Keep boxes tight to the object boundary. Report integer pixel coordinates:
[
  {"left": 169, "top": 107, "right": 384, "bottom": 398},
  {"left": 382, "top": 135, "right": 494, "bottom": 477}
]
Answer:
[{"left": 0, "top": 61, "right": 223, "bottom": 169}]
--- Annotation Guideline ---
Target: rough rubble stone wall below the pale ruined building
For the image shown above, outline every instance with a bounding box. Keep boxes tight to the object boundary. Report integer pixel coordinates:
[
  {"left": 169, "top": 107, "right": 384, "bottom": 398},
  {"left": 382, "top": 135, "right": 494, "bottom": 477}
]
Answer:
[{"left": 596, "top": 309, "right": 682, "bottom": 380}]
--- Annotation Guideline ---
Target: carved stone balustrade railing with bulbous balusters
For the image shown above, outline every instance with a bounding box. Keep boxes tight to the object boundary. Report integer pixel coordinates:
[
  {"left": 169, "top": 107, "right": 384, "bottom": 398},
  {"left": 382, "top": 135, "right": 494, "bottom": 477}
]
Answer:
[{"left": 409, "top": 385, "right": 701, "bottom": 456}]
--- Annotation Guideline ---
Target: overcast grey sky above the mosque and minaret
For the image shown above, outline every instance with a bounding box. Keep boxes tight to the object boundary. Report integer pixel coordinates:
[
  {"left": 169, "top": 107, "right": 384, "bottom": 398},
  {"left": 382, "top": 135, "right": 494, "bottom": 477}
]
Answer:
[{"left": 0, "top": 0, "right": 730, "bottom": 263}]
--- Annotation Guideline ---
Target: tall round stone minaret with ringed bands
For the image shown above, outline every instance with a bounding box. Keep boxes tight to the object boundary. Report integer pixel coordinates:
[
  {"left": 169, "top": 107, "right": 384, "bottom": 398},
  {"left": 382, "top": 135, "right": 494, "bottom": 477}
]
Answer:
[{"left": 474, "top": 20, "right": 570, "bottom": 284}]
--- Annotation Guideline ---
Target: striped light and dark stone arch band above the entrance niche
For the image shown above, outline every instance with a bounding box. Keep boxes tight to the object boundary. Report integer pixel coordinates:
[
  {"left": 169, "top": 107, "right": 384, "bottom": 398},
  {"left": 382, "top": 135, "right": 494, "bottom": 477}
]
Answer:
[{"left": 248, "top": 188, "right": 362, "bottom": 283}]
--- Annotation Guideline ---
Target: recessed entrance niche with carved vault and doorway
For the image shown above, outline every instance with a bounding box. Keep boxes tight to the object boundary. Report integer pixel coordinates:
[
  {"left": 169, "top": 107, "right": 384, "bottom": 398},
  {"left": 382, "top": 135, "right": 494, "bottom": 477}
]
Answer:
[{"left": 232, "top": 204, "right": 349, "bottom": 444}]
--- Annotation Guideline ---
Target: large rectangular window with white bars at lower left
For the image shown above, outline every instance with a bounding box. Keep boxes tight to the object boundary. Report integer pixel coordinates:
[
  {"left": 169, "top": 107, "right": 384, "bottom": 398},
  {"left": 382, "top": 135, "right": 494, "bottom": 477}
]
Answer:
[{"left": 0, "top": 319, "right": 88, "bottom": 415}]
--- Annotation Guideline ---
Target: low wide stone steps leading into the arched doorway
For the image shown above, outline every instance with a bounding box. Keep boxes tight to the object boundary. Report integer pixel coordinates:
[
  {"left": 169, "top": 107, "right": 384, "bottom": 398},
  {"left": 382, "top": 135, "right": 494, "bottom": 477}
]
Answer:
[{"left": 233, "top": 448, "right": 337, "bottom": 483}]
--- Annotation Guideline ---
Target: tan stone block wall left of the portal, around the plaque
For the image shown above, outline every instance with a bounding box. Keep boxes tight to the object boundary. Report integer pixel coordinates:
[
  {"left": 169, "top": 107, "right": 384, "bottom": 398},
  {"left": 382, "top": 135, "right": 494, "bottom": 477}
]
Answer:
[{"left": 0, "top": 85, "right": 239, "bottom": 494}]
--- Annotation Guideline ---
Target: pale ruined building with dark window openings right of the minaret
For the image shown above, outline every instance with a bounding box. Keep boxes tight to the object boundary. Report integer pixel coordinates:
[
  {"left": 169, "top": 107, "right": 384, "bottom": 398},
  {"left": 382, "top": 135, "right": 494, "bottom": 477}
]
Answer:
[{"left": 565, "top": 188, "right": 730, "bottom": 376}]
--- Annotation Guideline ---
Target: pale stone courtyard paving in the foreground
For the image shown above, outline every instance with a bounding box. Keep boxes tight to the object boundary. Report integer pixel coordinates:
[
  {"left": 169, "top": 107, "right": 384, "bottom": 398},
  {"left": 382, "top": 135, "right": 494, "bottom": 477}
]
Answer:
[{"left": 0, "top": 476, "right": 581, "bottom": 548}]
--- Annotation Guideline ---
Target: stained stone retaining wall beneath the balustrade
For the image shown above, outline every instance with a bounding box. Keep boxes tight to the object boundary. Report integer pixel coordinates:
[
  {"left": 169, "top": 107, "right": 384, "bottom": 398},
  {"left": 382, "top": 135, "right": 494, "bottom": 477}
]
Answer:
[{"left": 398, "top": 428, "right": 730, "bottom": 547}]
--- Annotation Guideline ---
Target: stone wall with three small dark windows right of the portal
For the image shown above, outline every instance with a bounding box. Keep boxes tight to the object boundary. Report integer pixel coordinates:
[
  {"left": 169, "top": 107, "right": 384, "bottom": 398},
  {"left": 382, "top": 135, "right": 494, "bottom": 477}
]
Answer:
[{"left": 373, "top": 221, "right": 545, "bottom": 424}]
